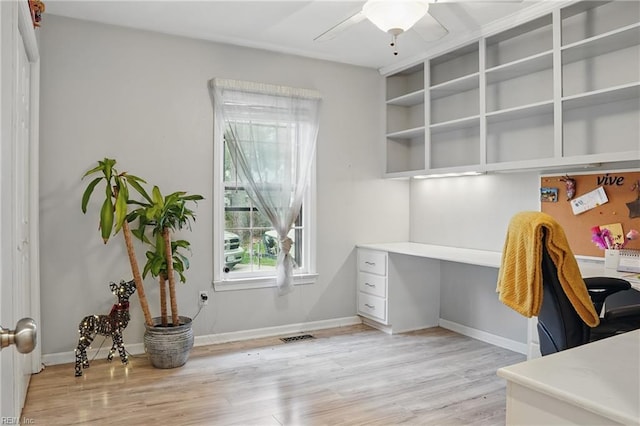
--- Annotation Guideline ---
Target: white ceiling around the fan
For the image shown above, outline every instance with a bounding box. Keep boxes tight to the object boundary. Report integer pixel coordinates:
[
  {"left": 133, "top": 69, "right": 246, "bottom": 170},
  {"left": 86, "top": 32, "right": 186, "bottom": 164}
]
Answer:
[{"left": 41, "top": 0, "right": 552, "bottom": 69}]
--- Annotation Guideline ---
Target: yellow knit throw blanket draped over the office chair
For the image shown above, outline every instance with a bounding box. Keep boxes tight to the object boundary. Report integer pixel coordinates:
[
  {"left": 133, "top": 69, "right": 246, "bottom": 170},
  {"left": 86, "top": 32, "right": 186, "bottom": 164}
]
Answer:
[{"left": 496, "top": 212, "right": 600, "bottom": 327}]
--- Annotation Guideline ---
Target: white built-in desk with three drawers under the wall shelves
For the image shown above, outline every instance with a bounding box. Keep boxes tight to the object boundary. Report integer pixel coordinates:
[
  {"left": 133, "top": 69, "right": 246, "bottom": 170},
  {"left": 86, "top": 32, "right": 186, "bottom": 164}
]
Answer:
[{"left": 357, "top": 242, "right": 640, "bottom": 358}]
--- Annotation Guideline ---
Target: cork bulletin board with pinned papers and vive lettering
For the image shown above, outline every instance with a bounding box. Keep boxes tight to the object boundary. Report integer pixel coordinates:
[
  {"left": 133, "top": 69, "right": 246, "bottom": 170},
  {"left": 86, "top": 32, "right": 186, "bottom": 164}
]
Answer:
[{"left": 540, "top": 171, "right": 640, "bottom": 257}]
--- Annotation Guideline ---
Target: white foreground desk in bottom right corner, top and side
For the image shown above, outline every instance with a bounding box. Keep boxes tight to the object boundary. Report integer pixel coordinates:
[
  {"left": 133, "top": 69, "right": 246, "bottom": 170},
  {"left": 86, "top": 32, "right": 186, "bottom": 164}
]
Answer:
[{"left": 498, "top": 330, "right": 640, "bottom": 425}]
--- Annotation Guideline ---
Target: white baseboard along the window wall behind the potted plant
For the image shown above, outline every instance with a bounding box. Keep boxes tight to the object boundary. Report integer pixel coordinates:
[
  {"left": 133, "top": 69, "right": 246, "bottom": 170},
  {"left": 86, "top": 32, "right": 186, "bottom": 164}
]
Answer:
[{"left": 42, "top": 316, "right": 362, "bottom": 365}]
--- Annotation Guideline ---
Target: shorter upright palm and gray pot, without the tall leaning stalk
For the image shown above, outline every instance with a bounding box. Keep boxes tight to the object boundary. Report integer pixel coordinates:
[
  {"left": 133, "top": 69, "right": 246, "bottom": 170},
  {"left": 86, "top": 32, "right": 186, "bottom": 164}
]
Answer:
[{"left": 129, "top": 186, "right": 203, "bottom": 368}]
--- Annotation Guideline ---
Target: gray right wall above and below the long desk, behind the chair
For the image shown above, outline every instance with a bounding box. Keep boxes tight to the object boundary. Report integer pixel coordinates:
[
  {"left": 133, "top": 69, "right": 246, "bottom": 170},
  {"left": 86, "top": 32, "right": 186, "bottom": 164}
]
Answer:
[{"left": 410, "top": 173, "right": 540, "bottom": 343}]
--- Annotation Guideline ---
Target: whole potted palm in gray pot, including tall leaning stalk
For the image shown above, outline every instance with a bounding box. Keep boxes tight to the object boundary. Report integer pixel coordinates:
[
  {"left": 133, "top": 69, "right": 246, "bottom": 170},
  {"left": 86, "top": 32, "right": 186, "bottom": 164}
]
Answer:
[{"left": 82, "top": 158, "right": 203, "bottom": 368}]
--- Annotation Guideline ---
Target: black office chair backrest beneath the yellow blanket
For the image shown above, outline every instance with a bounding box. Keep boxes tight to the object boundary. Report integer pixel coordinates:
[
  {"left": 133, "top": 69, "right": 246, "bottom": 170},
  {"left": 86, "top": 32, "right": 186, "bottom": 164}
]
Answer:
[{"left": 538, "top": 229, "right": 590, "bottom": 356}]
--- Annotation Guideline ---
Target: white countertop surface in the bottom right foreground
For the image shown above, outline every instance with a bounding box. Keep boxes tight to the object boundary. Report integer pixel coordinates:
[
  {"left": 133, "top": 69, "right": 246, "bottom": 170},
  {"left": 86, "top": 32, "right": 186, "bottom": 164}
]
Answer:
[{"left": 498, "top": 330, "right": 640, "bottom": 425}]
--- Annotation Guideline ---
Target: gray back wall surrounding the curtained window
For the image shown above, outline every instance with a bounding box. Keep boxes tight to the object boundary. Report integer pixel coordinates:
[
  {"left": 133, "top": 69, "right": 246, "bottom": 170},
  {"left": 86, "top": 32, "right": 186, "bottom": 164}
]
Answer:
[{"left": 40, "top": 16, "right": 409, "bottom": 354}]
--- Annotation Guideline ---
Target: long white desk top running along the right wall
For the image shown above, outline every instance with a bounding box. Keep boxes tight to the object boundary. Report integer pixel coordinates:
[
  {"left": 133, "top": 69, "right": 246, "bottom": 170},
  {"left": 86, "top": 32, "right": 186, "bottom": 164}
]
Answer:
[{"left": 358, "top": 242, "right": 640, "bottom": 290}]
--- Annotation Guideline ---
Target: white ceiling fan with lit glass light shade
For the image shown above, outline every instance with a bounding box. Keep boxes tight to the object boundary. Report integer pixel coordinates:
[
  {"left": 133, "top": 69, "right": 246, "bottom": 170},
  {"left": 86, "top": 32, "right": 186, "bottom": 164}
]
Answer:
[{"left": 314, "top": 0, "right": 522, "bottom": 55}]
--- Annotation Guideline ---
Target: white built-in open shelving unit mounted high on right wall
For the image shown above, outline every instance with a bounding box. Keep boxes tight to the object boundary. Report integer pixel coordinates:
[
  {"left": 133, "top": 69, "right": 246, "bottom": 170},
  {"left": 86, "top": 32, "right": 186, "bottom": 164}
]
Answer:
[{"left": 385, "top": 1, "right": 640, "bottom": 177}]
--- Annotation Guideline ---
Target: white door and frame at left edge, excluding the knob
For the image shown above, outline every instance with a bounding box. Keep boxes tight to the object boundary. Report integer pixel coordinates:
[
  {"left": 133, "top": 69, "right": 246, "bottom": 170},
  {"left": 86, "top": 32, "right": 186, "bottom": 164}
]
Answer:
[{"left": 0, "top": 1, "right": 40, "bottom": 421}]
